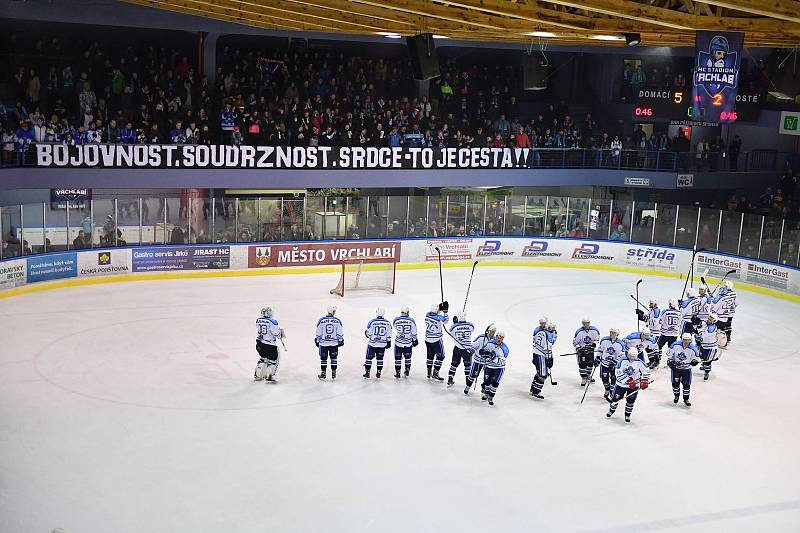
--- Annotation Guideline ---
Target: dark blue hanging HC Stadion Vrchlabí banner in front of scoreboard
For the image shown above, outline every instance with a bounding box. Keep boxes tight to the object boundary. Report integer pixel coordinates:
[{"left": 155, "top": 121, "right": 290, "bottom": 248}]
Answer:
[{"left": 692, "top": 31, "right": 744, "bottom": 123}]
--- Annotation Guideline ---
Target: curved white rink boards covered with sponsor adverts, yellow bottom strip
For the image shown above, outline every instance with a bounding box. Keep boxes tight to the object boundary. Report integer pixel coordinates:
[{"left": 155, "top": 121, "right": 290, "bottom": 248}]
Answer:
[{"left": 0, "top": 237, "right": 800, "bottom": 302}]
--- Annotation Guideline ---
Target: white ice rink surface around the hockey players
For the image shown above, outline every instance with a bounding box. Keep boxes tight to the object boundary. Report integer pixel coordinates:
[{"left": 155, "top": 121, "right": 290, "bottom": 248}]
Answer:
[{"left": 0, "top": 266, "right": 800, "bottom": 533}]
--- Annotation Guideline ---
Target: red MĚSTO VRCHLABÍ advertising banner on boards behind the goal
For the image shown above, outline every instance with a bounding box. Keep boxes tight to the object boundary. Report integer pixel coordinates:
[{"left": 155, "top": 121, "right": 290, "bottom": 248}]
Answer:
[{"left": 247, "top": 241, "right": 400, "bottom": 268}]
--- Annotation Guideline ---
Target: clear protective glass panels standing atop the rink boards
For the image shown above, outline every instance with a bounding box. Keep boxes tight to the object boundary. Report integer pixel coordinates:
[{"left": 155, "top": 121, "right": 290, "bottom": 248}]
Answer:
[{"left": 0, "top": 192, "right": 800, "bottom": 267}]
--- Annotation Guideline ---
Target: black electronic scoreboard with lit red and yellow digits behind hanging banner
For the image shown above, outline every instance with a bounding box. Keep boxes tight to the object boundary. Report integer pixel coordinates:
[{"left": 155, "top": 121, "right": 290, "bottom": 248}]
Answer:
[{"left": 633, "top": 89, "right": 762, "bottom": 123}]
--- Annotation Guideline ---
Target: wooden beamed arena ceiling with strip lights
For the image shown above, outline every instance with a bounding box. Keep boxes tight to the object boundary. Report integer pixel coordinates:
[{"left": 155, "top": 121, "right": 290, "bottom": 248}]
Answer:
[{"left": 123, "top": 0, "right": 800, "bottom": 48}]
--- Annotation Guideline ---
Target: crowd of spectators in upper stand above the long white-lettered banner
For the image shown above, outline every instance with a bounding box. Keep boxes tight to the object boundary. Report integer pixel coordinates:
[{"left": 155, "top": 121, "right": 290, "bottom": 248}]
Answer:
[{"left": 0, "top": 28, "right": 714, "bottom": 166}]
